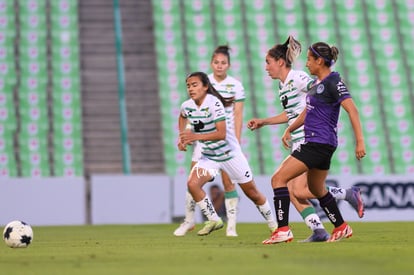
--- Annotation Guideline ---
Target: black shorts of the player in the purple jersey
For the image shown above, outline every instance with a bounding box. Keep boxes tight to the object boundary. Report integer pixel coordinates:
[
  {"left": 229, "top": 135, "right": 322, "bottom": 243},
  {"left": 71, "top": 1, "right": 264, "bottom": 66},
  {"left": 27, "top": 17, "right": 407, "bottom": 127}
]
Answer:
[{"left": 291, "top": 142, "right": 336, "bottom": 170}]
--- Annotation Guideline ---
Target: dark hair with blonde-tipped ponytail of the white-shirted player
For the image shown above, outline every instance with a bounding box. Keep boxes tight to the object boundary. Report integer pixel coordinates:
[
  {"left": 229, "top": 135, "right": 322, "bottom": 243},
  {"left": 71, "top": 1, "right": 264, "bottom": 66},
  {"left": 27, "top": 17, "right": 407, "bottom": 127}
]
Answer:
[{"left": 267, "top": 35, "right": 302, "bottom": 67}]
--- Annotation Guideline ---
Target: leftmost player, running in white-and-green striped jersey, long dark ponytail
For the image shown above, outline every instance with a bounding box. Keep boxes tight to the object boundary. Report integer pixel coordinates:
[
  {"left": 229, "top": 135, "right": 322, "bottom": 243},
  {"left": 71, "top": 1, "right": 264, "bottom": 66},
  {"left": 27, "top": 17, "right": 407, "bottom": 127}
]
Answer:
[{"left": 178, "top": 72, "right": 277, "bottom": 236}]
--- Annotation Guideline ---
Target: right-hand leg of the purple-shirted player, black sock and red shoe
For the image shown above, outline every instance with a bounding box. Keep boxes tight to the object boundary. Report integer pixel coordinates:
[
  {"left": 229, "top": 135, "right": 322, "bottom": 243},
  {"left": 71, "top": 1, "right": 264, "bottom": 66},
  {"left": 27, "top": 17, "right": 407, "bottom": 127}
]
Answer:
[{"left": 308, "top": 169, "right": 352, "bottom": 242}]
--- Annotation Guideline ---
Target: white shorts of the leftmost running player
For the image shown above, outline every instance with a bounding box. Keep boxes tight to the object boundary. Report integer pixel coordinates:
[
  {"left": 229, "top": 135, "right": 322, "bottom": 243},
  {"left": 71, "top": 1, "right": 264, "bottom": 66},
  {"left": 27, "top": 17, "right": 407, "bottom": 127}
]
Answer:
[{"left": 194, "top": 152, "right": 253, "bottom": 184}]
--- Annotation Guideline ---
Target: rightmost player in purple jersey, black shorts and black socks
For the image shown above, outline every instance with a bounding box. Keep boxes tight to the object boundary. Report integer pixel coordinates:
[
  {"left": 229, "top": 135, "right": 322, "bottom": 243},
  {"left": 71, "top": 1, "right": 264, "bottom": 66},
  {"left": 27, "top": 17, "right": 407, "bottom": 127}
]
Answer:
[{"left": 263, "top": 42, "right": 366, "bottom": 244}]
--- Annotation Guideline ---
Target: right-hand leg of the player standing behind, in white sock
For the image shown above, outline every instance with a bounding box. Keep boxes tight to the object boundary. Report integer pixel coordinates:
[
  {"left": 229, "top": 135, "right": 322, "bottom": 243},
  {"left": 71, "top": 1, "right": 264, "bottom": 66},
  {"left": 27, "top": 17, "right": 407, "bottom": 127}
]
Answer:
[{"left": 221, "top": 170, "right": 239, "bottom": 237}]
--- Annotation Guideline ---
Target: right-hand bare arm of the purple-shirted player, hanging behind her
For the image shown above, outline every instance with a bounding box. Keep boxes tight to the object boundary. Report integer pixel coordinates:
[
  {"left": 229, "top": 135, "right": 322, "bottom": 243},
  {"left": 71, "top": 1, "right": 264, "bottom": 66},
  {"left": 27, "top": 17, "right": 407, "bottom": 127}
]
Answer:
[{"left": 341, "top": 98, "right": 366, "bottom": 160}]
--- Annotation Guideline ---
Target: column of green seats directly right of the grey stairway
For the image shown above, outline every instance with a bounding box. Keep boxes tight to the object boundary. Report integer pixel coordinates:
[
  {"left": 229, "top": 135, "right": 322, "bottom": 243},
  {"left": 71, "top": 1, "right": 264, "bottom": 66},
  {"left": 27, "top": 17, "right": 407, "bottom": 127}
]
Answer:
[{"left": 153, "top": 1, "right": 191, "bottom": 175}]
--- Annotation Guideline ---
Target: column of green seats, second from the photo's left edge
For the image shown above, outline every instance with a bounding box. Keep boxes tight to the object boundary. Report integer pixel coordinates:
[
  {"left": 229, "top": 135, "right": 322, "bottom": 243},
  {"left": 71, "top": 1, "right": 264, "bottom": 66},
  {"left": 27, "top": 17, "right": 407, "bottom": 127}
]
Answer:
[{"left": 17, "top": 0, "right": 51, "bottom": 177}]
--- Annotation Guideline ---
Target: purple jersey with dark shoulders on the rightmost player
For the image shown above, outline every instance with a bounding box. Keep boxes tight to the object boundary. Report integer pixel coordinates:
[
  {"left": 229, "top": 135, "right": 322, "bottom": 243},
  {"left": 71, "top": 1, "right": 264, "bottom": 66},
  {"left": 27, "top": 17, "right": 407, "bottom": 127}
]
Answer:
[{"left": 304, "top": 72, "right": 351, "bottom": 147}]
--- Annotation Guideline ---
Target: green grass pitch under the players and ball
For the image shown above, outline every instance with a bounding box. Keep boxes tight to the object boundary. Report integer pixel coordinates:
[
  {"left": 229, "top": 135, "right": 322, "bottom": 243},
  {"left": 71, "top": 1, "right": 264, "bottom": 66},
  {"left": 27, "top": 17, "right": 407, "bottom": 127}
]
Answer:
[{"left": 0, "top": 222, "right": 414, "bottom": 275}]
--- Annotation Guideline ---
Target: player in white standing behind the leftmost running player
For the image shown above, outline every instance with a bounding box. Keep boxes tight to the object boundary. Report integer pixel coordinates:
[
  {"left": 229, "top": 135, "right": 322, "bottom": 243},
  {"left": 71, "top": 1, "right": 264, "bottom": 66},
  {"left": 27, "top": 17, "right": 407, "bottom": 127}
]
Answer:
[{"left": 174, "top": 45, "right": 245, "bottom": 237}]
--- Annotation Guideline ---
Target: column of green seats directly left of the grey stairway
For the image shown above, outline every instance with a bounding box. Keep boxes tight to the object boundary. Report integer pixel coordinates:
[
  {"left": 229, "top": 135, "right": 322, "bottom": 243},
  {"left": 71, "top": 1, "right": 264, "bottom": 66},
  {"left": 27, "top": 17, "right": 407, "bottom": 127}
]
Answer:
[{"left": 50, "top": 1, "right": 83, "bottom": 176}]
